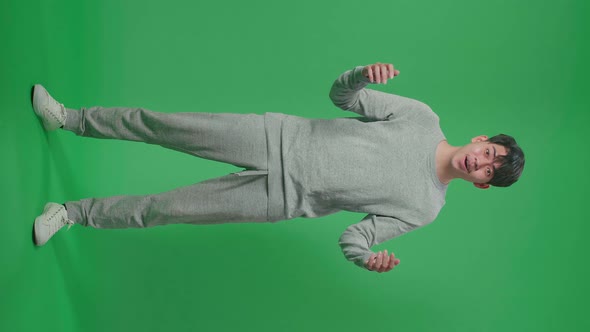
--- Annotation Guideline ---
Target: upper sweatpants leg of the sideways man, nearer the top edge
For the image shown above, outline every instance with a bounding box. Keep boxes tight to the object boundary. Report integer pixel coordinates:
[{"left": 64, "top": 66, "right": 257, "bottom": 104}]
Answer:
[{"left": 64, "top": 107, "right": 267, "bottom": 170}]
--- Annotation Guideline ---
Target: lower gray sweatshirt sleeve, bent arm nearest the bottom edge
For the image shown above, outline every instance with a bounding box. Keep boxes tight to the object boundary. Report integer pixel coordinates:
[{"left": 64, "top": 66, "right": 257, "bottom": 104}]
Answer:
[{"left": 338, "top": 214, "right": 418, "bottom": 269}]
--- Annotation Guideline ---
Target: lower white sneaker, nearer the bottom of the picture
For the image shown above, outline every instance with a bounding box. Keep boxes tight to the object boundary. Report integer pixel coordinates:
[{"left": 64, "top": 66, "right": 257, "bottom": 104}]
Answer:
[{"left": 34, "top": 203, "right": 74, "bottom": 246}]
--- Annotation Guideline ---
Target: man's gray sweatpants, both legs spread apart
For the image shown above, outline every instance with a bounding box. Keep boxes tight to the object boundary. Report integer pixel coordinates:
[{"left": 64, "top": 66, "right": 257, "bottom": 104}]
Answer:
[{"left": 64, "top": 107, "right": 282, "bottom": 228}]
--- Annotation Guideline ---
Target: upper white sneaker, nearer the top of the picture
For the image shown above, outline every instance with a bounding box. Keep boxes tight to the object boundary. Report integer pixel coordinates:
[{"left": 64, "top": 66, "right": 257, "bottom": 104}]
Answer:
[{"left": 33, "top": 84, "right": 66, "bottom": 130}]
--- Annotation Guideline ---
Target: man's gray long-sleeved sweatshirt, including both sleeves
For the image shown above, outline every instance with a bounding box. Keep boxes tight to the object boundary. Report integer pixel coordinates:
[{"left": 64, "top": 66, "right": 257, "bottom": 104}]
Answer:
[{"left": 265, "top": 66, "right": 447, "bottom": 267}]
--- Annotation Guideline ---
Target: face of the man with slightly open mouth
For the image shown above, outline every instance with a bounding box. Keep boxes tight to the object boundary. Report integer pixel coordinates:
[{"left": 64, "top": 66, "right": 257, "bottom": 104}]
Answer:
[{"left": 452, "top": 136, "right": 507, "bottom": 189}]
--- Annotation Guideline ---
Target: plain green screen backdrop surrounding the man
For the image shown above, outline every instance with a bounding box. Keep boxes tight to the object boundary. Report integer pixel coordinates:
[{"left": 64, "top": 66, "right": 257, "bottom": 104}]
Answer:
[{"left": 0, "top": 0, "right": 590, "bottom": 332}]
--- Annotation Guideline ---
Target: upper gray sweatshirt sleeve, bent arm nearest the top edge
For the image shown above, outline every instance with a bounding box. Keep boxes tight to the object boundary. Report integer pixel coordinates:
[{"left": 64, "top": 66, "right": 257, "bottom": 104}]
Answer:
[{"left": 330, "top": 66, "right": 432, "bottom": 120}]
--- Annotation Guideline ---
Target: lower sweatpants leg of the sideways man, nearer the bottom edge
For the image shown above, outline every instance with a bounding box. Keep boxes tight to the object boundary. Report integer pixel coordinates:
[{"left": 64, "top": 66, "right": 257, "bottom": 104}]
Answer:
[{"left": 65, "top": 171, "right": 277, "bottom": 228}]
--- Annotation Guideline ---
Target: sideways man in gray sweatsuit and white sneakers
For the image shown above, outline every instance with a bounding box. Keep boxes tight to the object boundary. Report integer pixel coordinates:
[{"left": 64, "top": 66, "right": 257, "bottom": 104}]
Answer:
[{"left": 33, "top": 63, "right": 524, "bottom": 272}]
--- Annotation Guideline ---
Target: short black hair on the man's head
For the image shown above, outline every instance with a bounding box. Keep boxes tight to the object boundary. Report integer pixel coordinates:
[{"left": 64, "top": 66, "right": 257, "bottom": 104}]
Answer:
[{"left": 487, "top": 134, "right": 524, "bottom": 187}]
